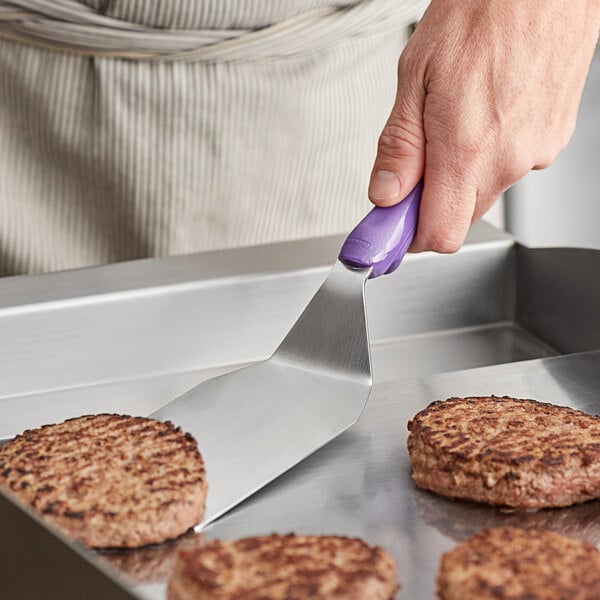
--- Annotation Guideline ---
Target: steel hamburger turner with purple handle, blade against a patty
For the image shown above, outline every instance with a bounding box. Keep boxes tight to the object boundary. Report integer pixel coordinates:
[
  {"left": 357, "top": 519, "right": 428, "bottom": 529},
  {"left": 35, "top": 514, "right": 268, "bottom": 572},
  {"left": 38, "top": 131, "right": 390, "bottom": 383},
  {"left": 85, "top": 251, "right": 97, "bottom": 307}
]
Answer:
[{"left": 150, "top": 183, "right": 422, "bottom": 529}]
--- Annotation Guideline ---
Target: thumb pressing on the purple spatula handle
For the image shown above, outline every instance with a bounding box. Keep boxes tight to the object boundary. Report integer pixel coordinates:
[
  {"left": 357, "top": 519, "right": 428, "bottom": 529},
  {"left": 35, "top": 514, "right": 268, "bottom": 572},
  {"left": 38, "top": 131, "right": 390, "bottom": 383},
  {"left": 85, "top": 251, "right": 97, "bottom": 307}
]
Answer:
[{"left": 369, "top": 66, "right": 425, "bottom": 206}]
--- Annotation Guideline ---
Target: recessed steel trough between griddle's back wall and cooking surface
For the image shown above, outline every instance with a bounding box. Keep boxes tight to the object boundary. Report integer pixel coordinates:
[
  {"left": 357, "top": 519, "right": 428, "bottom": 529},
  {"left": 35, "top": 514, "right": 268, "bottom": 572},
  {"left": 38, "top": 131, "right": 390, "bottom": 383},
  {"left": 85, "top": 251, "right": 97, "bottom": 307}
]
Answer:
[{"left": 0, "top": 322, "right": 557, "bottom": 448}]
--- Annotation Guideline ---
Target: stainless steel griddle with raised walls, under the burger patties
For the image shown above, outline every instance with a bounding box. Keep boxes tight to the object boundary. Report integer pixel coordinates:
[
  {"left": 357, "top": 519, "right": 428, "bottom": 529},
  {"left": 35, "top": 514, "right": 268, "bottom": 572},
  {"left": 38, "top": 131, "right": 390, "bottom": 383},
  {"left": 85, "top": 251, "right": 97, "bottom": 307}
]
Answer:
[{"left": 0, "top": 224, "right": 600, "bottom": 600}]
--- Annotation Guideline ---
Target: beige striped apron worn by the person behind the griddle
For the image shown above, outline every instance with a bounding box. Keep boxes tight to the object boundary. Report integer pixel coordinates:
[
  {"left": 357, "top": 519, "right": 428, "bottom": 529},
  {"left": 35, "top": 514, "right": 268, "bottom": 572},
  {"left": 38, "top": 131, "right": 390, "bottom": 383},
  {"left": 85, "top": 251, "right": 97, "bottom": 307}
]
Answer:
[{"left": 0, "top": 0, "right": 426, "bottom": 274}]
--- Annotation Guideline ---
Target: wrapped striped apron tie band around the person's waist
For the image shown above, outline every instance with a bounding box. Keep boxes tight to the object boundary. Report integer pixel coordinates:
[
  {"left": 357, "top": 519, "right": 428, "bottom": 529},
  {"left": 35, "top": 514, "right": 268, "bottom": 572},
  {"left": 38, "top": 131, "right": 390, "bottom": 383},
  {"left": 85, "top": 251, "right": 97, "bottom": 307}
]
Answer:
[{"left": 0, "top": 0, "right": 424, "bottom": 62}]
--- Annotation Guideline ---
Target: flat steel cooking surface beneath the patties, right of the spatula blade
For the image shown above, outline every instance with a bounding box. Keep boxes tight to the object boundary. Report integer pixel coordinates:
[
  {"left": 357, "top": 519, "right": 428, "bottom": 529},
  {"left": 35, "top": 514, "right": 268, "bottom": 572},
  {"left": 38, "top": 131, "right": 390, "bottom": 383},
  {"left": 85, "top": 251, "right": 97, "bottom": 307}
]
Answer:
[{"left": 184, "top": 352, "right": 600, "bottom": 600}]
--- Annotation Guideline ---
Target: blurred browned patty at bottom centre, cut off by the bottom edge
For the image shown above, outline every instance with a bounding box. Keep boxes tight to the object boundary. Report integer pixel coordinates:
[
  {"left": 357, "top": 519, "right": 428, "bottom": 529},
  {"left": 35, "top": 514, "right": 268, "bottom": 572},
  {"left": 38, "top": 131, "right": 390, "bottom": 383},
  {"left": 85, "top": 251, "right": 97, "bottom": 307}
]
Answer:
[{"left": 168, "top": 535, "right": 399, "bottom": 600}]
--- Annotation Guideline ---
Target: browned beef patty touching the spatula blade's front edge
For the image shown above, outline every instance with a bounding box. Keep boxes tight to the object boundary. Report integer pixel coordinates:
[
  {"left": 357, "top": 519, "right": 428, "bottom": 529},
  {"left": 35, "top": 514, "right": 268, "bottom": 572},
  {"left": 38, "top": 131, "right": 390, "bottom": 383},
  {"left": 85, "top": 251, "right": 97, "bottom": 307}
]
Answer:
[{"left": 0, "top": 414, "right": 207, "bottom": 548}]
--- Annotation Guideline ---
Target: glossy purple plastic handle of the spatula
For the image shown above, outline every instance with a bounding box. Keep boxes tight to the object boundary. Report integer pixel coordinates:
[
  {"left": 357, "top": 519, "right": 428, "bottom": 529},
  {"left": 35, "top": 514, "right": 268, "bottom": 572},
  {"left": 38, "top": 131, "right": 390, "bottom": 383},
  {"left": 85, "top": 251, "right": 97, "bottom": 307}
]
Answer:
[{"left": 339, "top": 180, "right": 423, "bottom": 278}]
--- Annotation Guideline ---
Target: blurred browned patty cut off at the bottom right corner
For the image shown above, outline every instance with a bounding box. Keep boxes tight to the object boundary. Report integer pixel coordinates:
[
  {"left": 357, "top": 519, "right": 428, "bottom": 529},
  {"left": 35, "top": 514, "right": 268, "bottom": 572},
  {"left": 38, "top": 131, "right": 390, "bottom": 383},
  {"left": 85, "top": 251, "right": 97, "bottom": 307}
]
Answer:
[{"left": 437, "top": 527, "right": 600, "bottom": 600}]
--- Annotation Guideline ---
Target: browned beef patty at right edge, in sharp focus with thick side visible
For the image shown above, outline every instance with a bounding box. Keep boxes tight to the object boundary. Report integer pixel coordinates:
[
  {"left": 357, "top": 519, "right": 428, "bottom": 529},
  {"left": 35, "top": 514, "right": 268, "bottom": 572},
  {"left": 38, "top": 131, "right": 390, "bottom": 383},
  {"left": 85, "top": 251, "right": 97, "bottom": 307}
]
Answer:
[{"left": 408, "top": 396, "right": 600, "bottom": 509}]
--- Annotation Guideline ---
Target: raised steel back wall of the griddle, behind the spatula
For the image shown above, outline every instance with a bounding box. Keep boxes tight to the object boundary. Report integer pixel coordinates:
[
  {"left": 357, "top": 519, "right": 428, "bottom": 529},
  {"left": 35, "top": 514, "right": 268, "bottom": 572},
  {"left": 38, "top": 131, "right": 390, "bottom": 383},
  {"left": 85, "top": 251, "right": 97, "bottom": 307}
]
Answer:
[{"left": 0, "top": 221, "right": 515, "bottom": 408}]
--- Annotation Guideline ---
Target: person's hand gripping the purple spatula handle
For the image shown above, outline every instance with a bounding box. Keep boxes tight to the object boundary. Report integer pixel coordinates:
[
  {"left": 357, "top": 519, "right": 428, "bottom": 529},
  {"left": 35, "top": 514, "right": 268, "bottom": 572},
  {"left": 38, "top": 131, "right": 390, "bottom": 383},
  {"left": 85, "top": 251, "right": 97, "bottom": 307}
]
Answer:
[{"left": 369, "top": 0, "right": 600, "bottom": 252}]
